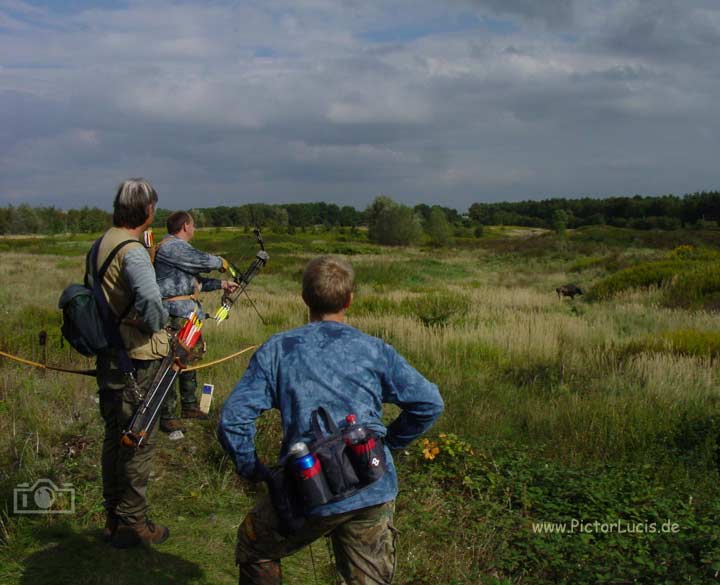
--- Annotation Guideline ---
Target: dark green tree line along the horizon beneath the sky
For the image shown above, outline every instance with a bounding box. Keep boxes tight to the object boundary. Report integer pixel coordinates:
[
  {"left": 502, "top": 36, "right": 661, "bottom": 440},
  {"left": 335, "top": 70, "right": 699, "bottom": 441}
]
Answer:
[{"left": 0, "top": 191, "right": 720, "bottom": 240}]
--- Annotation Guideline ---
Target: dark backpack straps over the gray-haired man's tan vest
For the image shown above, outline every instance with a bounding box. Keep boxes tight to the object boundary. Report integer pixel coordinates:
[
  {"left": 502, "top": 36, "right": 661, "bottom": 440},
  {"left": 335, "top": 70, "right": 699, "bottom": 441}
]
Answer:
[{"left": 85, "top": 237, "right": 139, "bottom": 374}]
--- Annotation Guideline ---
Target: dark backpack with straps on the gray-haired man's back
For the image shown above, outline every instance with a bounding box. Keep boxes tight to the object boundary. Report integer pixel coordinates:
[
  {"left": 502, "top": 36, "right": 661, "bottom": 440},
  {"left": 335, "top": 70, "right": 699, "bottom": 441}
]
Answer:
[{"left": 58, "top": 238, "right": 137, "bottom": 364}]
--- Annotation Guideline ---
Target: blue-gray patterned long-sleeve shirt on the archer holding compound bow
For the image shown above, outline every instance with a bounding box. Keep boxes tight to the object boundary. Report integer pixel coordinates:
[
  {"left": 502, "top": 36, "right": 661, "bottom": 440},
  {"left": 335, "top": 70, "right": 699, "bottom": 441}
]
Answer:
[{"left": 155, "top": 235, "right": 222, "bottom": 317}]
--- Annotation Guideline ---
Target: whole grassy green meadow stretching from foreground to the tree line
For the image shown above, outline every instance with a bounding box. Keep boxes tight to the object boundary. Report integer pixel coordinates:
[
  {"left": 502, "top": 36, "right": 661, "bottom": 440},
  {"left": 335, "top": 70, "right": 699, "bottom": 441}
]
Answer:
[{"left": 0, "top": 227, "right": 720, "bottom": 585}]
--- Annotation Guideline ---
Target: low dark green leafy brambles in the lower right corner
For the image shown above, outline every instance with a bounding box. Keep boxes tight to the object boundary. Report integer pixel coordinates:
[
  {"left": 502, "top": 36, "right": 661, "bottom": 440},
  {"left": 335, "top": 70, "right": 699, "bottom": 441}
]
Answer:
[{"left": 401, "top": 434, "right": 720, "bottom": 585}]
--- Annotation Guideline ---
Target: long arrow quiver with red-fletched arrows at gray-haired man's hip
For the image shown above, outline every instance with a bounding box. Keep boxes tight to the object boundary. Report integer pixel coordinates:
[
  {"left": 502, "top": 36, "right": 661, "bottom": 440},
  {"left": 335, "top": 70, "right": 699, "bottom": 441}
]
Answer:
[{"left": 121, "top": 324, "right": 205, "bottom": 447}]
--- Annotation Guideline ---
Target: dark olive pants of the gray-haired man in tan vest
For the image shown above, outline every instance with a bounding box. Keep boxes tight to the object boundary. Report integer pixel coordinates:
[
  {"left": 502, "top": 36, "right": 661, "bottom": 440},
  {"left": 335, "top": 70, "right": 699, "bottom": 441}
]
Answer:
[{"left": 97, "top": 354, "right": 162, "bottom": 524}]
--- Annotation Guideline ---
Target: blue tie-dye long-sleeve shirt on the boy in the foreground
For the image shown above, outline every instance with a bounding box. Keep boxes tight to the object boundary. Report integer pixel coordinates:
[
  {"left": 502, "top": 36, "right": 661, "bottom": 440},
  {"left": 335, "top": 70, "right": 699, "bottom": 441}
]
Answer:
[{"left": 218, "top": 321, "right": 443, "bottom": 516}]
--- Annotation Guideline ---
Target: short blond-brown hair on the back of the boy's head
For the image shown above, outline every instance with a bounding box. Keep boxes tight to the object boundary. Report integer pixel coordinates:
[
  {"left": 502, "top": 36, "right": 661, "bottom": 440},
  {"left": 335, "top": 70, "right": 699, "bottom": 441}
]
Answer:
[{"left": 303, "top": 256, "right": 355, "bottom": 315}]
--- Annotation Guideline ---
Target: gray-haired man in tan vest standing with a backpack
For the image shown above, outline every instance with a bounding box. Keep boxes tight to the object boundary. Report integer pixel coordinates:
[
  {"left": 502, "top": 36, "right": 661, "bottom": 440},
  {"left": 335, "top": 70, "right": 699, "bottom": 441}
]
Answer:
[{"left": 93, "top": 179, "right": 170, "bottom": 548}]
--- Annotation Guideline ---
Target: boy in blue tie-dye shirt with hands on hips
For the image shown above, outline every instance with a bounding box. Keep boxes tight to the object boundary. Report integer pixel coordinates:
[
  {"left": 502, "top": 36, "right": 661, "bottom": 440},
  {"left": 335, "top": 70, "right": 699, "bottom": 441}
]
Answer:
[{"left": 218, "top": 256, "right": 444, "bottom": 585}]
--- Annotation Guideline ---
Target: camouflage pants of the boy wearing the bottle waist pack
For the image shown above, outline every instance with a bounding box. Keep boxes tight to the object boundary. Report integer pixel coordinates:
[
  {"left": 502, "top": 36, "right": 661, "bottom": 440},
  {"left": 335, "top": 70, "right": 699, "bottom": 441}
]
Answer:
[{"left": 235, "top": 498, "right": 397, "bottom": 585}]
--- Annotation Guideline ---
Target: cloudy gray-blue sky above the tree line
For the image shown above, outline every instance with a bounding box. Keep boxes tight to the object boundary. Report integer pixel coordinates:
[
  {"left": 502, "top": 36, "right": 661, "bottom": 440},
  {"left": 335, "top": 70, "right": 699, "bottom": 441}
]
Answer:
[{"left": 0, "top": 0, "right": 720, "bottom": 211}]
